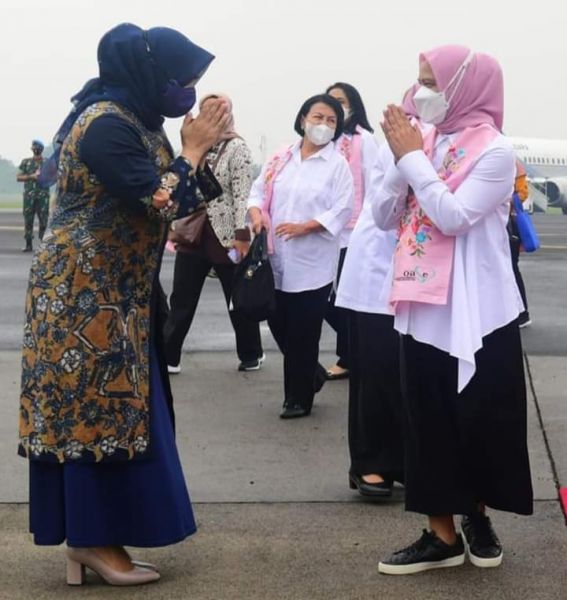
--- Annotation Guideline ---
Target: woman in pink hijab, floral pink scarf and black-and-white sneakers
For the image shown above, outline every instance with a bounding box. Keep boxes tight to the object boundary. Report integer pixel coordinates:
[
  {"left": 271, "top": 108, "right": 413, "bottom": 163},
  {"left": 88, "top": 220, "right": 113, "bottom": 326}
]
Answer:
[{"left": 372, "top": 46, "right": 533, "bottom": 575}]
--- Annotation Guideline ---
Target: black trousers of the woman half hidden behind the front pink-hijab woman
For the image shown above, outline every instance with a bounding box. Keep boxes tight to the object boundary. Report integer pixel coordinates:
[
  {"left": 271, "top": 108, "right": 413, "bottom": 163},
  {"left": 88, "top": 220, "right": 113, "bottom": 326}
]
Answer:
[{"left": 346, "top": 310, "right": 404, "bottom": 481}]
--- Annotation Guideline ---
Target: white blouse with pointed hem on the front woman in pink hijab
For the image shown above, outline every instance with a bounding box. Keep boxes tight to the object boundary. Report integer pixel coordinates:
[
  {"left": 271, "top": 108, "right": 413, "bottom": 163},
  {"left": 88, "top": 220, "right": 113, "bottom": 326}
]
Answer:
[{"left": 372, "top": 134, "right": 523, "bottom": 392}]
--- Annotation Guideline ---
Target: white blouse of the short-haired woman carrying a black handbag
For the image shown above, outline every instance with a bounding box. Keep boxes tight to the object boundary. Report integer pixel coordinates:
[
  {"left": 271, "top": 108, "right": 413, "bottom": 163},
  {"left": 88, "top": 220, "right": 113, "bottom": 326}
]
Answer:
[{"left": 248, "top": 141, "right": 354, "bottom": 292}]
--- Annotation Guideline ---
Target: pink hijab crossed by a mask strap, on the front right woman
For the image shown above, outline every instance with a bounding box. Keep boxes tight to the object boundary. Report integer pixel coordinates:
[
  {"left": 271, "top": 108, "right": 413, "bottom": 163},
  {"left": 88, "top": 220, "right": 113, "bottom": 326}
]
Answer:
[{"left": 422, "top": 45, "right": 504, "bottom": 133}]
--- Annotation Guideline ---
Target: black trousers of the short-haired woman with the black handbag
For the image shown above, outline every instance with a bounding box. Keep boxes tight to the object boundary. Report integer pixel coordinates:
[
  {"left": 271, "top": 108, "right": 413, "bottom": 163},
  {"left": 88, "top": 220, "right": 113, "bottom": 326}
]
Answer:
[{"left": 268, "top": 284, "right": 331, "bottom": 410}]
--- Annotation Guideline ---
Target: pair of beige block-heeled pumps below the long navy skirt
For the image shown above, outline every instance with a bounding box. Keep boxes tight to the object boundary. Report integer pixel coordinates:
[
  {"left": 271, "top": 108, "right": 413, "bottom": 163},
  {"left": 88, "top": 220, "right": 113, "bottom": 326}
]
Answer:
[{"left": 66, "top": 548, "right": 160, "bottom": 585}]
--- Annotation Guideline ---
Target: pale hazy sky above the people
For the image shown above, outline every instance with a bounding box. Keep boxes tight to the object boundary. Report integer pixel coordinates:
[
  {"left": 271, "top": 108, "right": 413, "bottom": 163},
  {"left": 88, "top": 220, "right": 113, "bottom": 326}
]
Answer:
[{"left": 0, "top": 0, "right": 567, "bottom": 162}]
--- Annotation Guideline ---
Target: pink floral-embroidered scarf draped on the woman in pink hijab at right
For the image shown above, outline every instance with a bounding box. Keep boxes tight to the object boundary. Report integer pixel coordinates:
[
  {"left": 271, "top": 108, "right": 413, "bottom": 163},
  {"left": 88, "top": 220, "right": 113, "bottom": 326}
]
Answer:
[{"left": 390, "top": 123, "right": 498, "bottom": 313}]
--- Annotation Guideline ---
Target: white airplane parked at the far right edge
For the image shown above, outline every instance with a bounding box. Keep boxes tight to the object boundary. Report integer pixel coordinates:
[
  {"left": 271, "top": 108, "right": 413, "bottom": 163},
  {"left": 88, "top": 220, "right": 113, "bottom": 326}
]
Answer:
[{"left": 512, "top": 138, "right": 567, "bottom": 215}]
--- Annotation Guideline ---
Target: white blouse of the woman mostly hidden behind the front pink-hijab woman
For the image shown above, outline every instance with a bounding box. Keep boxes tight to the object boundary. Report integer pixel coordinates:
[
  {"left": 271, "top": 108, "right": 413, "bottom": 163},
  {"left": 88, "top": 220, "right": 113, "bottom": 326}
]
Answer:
[{"left": 335, "top": 144, "right": 396, "bottom": 314}]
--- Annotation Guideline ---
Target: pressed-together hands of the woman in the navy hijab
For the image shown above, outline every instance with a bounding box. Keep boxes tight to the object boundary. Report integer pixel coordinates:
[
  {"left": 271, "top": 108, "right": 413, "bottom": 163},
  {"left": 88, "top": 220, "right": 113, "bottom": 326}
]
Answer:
[{"left": 181, "top": 98, "right": 230, "bottom": 167}]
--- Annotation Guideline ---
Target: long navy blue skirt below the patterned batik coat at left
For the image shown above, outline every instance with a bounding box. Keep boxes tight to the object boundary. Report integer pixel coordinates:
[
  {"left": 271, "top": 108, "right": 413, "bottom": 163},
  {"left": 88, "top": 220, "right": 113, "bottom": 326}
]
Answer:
[{"left": 30, "top": 351, "right": 196, "bottom": 548}]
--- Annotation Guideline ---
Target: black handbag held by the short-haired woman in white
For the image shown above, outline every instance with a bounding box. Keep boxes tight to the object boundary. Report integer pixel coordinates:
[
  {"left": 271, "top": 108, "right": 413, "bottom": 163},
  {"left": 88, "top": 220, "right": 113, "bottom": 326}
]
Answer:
[{"left": 231, "top": 229, "right": 276, "bottom": 322}]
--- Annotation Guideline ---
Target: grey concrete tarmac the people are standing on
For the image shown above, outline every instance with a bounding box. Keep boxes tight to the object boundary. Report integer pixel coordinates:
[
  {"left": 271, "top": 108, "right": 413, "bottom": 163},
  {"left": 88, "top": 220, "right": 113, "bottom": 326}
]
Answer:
[{"left": 0, "top": 210, "right": 567, "bottom": 600}]
